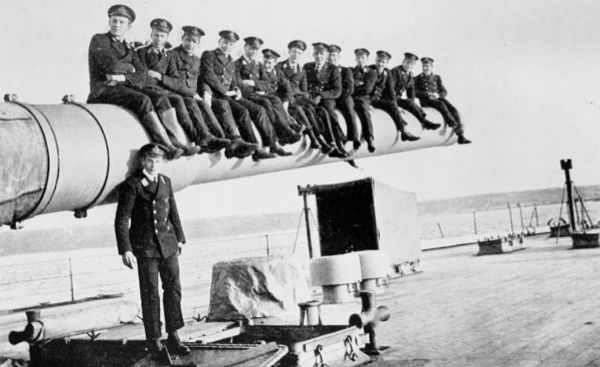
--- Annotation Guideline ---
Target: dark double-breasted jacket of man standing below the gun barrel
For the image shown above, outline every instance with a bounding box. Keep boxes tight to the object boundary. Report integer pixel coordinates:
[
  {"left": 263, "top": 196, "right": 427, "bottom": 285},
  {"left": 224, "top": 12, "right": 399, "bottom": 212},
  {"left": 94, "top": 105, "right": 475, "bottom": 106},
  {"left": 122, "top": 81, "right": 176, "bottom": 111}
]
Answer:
[{"left": 115, "top": 171, "right": 185, "bottom": 258}]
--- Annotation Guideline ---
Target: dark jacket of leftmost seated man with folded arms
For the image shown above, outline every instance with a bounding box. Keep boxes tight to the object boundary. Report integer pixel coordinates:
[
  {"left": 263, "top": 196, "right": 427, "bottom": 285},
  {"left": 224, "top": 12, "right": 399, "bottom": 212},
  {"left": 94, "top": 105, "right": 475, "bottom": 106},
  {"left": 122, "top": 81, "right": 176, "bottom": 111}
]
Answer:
[{"left": 88, "top": 32, "right": 149, "bottom": 96}]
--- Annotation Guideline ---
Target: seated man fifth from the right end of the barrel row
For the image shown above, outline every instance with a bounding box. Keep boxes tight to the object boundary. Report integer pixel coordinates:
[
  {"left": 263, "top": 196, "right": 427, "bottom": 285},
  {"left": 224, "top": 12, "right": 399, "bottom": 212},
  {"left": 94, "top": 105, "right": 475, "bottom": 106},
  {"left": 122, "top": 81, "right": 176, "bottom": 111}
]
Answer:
[{"left": 328, "top": 45, "right": 361, "bottom": 150}]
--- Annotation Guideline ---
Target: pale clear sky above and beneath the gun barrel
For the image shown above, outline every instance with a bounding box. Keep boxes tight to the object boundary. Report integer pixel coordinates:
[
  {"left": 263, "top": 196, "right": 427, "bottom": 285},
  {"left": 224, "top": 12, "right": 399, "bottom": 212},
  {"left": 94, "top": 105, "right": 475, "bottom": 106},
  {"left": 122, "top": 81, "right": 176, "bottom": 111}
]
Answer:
[{"left": 0, "top": 0, "right": 600, "bottom": 228}]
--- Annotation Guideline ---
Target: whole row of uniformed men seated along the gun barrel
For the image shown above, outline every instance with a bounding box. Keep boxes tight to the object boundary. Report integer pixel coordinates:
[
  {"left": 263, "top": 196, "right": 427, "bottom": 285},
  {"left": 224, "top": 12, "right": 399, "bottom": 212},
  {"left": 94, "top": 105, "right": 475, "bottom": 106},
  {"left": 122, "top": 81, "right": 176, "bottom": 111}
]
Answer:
[{"left": 88, "top": 5, "right": 469, "bottom": 160}]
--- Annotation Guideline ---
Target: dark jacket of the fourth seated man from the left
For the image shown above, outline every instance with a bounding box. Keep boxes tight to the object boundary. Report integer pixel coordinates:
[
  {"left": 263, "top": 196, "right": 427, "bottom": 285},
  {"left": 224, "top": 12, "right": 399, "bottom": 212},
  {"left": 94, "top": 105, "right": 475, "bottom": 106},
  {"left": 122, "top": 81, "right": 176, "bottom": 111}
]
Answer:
[{"left": 200, "top": 48, "right": 238, "bottom": 98}]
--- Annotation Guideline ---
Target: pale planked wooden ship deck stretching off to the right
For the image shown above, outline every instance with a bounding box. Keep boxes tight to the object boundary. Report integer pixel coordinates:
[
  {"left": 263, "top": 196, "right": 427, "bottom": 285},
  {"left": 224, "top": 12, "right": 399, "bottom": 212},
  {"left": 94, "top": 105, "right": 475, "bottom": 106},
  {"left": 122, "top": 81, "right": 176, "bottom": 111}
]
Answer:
[{"left": 4, "top": 237, "right": 600, "bottom": 367}]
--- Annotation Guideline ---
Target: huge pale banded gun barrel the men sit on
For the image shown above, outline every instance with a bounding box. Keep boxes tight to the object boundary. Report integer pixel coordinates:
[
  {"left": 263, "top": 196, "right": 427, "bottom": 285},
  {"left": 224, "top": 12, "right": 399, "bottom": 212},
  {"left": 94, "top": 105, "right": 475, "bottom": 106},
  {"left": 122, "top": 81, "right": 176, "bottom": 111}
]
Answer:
[{"left": 0, "top": 100, "right": 456, "bottom": 226}]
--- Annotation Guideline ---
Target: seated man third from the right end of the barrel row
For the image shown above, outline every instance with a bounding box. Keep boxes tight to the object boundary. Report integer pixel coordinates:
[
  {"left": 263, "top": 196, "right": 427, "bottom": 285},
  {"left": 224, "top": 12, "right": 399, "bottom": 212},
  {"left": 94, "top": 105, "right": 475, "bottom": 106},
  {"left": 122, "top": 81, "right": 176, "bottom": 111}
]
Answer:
[{"left": 371, "top": 51, "right": 420, "bottom": 141}]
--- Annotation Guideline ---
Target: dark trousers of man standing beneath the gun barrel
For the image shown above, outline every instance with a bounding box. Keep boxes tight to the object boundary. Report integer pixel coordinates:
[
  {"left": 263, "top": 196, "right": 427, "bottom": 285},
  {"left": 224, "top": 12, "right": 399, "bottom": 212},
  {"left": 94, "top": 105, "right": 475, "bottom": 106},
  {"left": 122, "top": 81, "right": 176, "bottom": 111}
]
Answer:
[{"left": 137, "top": 254, "right": 184, "bottom": 340}]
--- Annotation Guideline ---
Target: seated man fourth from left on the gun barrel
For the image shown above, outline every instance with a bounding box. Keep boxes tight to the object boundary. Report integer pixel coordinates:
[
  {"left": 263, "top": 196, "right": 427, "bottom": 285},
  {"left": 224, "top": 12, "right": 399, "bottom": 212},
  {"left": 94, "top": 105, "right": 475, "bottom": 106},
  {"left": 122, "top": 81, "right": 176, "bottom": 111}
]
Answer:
[{"left": 200, "top": 30, "right": 276, "bottom": 160}]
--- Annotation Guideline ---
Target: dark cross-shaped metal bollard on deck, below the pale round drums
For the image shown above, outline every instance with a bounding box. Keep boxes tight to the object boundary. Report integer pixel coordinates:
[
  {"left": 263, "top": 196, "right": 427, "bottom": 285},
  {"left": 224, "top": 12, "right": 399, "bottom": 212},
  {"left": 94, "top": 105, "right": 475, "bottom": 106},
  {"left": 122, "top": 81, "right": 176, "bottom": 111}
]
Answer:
[{"left": 348, "top": 291, "right": 390, "bottom": 355}]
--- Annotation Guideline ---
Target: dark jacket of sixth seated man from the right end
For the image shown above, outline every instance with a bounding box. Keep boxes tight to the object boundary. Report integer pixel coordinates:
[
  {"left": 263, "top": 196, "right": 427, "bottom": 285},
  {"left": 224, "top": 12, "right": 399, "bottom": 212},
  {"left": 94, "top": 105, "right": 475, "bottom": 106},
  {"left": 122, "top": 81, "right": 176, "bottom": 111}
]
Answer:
[{"left": 303, "top": 62, "right": 342, "bottom": 100}]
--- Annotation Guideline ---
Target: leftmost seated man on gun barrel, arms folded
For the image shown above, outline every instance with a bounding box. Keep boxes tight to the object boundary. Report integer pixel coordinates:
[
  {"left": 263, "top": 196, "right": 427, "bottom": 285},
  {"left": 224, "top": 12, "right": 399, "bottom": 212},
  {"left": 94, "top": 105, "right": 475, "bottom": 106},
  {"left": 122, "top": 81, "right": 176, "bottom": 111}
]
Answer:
[{"left": 87, "top": 5, "right": 183, "bottom": 159}]
